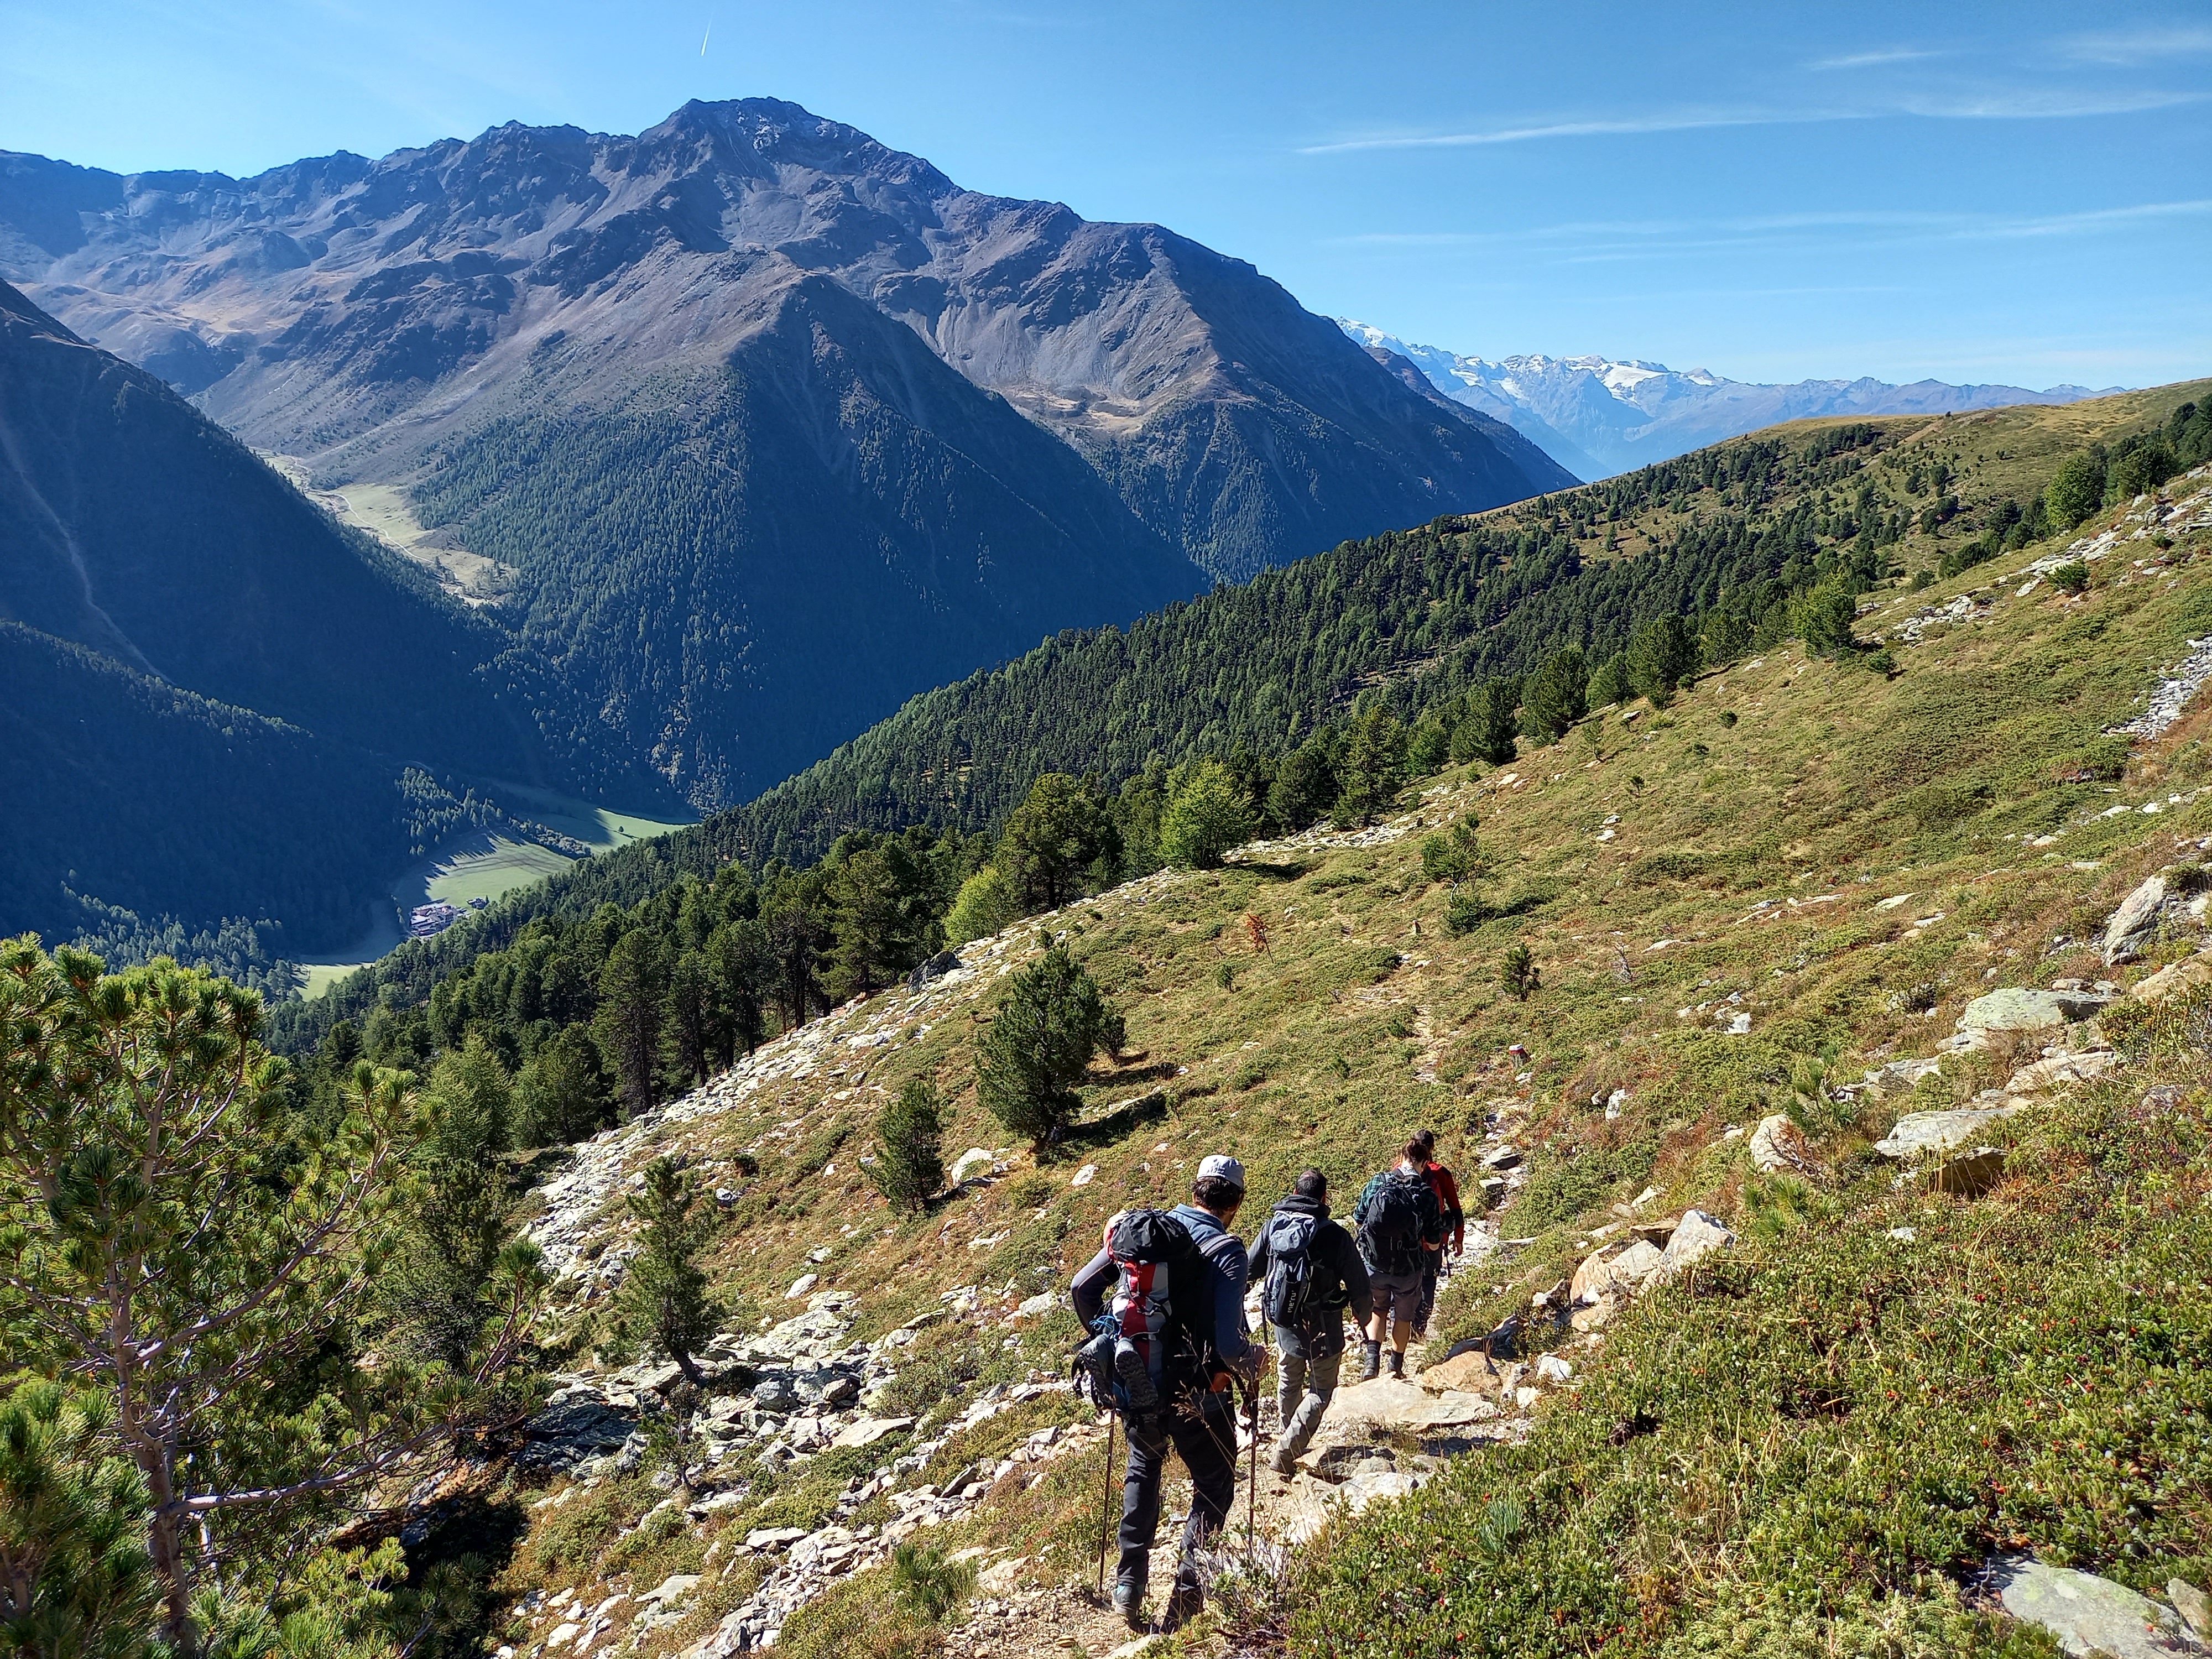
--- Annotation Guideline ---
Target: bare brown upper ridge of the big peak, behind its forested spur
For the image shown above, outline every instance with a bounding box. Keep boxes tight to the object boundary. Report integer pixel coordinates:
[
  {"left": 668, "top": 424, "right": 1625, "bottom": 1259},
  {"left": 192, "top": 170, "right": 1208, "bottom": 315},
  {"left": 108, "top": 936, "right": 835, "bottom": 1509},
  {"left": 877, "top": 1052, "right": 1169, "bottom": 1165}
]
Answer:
[{"left": 0, "top": 100, "right": 1559, "bottom": 593}]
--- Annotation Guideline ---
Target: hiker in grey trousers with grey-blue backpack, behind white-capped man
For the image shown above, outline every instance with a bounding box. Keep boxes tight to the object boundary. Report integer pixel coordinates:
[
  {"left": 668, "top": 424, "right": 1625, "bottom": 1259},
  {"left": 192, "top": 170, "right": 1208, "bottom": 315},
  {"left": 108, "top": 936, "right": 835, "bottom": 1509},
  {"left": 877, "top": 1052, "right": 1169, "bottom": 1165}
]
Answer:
[{"left": 1252, "top": 1170, "right": 1369, "bottom": 1478}]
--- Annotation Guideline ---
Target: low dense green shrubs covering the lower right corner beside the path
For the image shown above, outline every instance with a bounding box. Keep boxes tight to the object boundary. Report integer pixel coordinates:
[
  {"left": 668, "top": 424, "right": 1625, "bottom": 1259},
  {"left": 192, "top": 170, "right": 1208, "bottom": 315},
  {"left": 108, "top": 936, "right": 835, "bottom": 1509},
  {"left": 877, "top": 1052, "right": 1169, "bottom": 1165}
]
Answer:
[{"left": 1287, "top": 1066, "right": 2212, "bottom": 1659}]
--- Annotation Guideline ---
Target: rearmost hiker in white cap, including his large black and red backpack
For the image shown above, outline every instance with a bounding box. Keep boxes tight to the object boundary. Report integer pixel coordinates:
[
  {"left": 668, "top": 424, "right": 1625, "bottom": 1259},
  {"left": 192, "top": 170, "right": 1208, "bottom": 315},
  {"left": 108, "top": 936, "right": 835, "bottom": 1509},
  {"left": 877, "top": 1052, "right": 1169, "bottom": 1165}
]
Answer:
[{"left": 1073, "top": 1152, "right": 1261, "bottom": 1630}]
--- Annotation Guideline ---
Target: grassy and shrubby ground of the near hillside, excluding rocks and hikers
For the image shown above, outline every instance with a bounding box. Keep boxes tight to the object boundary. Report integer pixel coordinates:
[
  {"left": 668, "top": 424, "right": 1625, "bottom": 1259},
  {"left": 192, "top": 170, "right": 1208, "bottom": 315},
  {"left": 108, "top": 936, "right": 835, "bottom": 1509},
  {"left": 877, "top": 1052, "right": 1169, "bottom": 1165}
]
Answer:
[{"left": 471, "top": 469, "right": 2212, "bottom": 1655}]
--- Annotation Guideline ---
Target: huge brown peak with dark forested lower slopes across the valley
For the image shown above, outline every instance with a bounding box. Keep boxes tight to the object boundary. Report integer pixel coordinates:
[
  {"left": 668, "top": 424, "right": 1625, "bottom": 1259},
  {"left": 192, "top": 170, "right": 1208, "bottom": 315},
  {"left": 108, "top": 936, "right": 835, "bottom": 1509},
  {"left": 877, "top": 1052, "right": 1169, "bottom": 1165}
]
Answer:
[{"left": 0, "top": 100, "right": 1566, "bottom": 807}]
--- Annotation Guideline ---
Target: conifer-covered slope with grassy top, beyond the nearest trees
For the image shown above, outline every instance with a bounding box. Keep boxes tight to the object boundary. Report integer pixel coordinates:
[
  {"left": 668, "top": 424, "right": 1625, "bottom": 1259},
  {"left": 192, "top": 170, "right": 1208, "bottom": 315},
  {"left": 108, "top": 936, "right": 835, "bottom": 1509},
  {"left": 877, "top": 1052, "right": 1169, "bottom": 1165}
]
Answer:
[{"left": 281, "top": 380, "right": 2212, "bottom": 1042}]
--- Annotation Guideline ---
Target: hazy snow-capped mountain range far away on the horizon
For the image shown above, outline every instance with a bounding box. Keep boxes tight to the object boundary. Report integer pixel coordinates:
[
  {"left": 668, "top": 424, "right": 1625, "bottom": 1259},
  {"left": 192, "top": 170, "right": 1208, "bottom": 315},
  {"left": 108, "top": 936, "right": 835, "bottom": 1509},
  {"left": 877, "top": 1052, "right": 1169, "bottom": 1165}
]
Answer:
[{"left": 1336, "top": 316, "right": 2121, "bottom": 480}]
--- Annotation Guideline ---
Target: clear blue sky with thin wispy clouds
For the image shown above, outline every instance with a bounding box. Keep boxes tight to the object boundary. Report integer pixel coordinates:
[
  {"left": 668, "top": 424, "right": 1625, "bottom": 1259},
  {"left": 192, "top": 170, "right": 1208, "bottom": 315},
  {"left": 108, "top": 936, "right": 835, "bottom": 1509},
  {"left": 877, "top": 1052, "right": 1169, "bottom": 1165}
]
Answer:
[{"left": 0, "top": 0, "right": 2212, "bottom": 387}]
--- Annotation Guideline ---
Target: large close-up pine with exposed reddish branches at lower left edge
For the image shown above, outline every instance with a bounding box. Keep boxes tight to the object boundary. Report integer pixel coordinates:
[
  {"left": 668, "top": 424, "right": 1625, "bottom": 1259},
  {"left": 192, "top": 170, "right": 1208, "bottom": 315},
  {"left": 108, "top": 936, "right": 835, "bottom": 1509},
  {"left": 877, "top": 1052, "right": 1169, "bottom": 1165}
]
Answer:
[{"left": 0, "top": 938, "right": 542, "bottom": 1659}]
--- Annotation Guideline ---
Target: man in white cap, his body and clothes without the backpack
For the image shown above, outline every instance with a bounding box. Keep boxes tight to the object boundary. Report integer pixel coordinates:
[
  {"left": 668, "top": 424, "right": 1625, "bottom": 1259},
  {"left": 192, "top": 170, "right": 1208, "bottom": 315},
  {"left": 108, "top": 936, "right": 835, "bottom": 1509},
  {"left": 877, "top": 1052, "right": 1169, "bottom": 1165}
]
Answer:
[{"left": 1073, "top": 1155, "right": 1261, "bottom": 1630}]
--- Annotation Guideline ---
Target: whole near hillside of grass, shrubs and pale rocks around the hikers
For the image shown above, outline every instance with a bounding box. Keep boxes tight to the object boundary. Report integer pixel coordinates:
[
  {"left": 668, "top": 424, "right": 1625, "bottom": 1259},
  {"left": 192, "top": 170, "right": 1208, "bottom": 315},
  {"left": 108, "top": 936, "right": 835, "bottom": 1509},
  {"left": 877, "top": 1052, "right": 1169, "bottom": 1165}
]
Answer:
[{"left": 436, "top": 469, "right": 2212, "bottom": 1659}]
